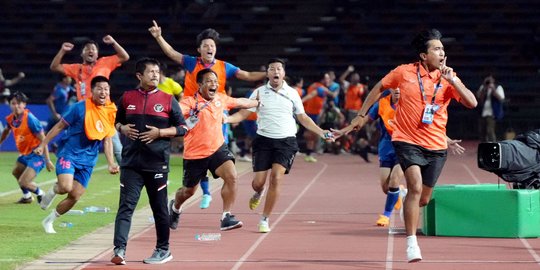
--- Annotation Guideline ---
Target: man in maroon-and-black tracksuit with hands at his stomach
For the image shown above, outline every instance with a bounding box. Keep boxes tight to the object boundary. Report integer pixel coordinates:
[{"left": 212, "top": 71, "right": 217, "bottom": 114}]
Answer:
[{"left": 111, "top": 58, "right": 187, "bottom": 265}]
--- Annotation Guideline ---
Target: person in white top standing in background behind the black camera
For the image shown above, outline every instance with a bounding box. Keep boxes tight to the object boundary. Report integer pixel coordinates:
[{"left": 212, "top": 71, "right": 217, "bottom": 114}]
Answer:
[{"left": 476, "top": 75, "right": 504, "bottom": 142}]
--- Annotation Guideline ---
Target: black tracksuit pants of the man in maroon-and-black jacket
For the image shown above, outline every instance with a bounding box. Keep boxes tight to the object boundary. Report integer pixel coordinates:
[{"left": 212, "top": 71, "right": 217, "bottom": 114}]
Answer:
[{"left": 114, "top": 168, "right": 170, "bottom": 250}]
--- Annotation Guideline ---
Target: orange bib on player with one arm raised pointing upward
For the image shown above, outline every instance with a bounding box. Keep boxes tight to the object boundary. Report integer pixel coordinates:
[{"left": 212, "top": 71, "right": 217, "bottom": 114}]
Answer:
[{"left": 184, "top": 57, "right": 227, "bottom": 97}]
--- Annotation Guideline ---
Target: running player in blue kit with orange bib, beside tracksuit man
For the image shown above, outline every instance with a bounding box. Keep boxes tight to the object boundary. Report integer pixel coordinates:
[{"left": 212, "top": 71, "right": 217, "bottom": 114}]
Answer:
[{"left": 34, "top": 76, "right": 119, "bottom": 233}]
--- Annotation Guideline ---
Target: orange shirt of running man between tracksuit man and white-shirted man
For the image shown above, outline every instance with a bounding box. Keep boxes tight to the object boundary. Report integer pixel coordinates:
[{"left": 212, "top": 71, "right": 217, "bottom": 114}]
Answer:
[{"left": 180, "top": 93, "right": 237, "bottom": 159}]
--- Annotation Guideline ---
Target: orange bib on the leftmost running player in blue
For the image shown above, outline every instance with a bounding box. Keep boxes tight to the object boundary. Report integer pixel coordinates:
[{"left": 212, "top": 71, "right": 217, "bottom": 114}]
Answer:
[{"left": 6, "top": 110, "right": 41, "bottom": 156}]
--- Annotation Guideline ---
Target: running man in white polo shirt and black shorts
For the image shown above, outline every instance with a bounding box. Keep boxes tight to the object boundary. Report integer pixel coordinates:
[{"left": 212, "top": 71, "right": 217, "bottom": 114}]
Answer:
[{"left": 226, "top": 58, "right": 331, "bottom": 233}]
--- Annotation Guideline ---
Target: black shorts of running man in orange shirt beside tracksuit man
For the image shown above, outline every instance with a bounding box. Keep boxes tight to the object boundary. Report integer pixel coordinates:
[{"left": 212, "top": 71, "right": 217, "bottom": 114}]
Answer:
[{"left": 183, "top": 144, "right": 234, "bottom": 188}]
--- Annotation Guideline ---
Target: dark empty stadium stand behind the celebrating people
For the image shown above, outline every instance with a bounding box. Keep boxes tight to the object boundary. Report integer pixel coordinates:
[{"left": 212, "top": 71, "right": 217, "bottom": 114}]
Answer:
[{"left": 0, "top": 0, "right": 540, "bottom": 138}]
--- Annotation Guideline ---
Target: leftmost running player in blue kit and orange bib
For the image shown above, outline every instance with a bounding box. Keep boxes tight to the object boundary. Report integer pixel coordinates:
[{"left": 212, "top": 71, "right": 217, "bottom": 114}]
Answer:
[{"left": 0, "top": 91, "right": 54, "bottom": 203}]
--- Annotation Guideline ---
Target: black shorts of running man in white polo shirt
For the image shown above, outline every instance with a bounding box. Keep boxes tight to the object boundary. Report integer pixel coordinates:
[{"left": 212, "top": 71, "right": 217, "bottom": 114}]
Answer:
[{"left": 252, "top": 134, "right": 298, "bottom": 174}]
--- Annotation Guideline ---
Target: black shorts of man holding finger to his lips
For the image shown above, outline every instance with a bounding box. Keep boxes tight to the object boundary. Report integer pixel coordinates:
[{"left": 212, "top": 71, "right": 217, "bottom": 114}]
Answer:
[{"left": 392, "top": 141, "right": 447, "bottom": 187}]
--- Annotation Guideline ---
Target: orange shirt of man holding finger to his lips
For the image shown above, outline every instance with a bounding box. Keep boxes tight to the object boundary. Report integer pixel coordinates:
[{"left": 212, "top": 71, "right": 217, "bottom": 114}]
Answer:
[{"left": 381, "top": 63, "right": 461, "bottom": 150}]
